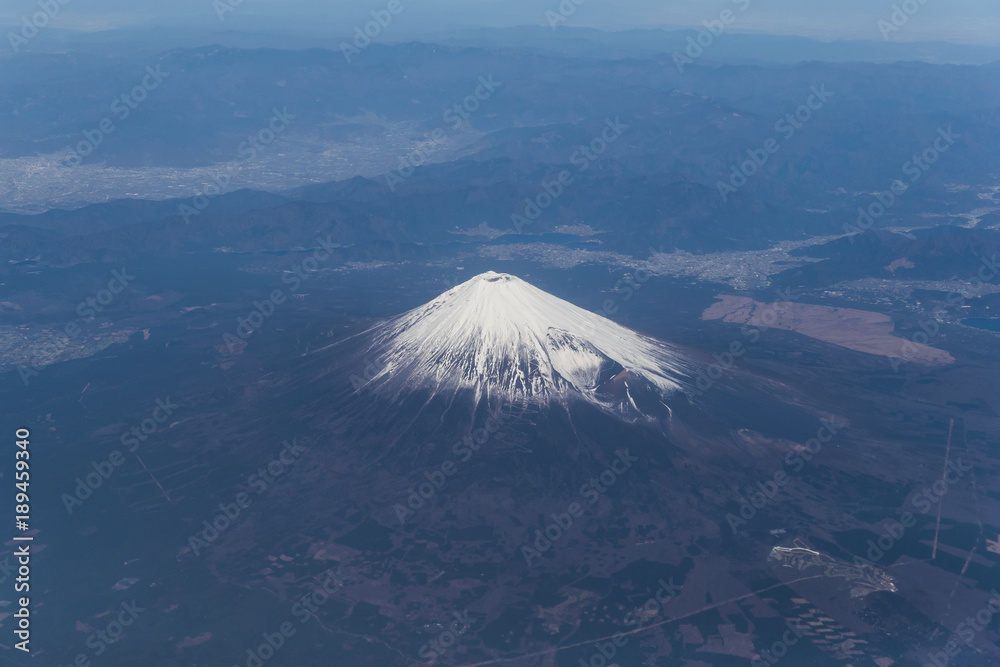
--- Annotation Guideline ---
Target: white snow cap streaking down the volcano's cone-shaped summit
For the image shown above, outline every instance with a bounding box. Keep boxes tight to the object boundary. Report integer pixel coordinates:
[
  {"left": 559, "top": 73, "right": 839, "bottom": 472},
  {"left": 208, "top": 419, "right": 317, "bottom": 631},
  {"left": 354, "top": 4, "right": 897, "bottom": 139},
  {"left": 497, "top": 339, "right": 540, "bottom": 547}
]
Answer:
[{"left": 360, "top": 271, "right": 687, "bottom": 412}]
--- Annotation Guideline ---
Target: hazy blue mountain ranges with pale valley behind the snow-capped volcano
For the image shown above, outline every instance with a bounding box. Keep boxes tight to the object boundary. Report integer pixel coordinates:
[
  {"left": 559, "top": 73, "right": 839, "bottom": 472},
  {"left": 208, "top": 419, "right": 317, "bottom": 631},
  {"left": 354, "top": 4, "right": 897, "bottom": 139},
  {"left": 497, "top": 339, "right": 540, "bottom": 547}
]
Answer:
[{"left": 0, "top": 34, "right": 1000, "bottom": 265}]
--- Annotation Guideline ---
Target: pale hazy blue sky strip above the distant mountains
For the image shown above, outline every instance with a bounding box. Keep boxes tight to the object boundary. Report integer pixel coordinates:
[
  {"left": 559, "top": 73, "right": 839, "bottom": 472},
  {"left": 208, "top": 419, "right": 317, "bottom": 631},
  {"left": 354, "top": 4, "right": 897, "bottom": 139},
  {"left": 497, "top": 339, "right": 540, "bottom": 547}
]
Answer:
[{"left": 0, "top": 0, "right": 1000, "bottom": 44}]
